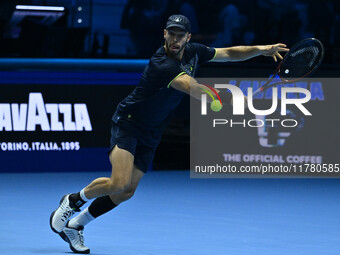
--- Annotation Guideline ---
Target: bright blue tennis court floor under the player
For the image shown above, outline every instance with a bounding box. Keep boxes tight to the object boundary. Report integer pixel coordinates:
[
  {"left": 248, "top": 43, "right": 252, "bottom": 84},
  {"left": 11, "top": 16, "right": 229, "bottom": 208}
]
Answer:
[{"left": 0, "top": 171, "right": 340, "bottom": 255}]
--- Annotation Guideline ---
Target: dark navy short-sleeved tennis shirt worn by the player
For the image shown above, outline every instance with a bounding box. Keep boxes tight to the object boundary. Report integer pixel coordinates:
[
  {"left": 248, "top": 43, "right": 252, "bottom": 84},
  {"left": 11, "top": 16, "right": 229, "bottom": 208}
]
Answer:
[{"left": 112, "top": 43, "right": 216, "bottom": 147}]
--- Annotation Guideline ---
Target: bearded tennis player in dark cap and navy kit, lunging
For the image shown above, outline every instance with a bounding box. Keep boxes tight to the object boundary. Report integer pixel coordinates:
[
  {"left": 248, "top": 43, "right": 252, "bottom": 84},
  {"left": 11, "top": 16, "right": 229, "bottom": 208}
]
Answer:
[{"left": 50, "top": 15, "right": 288, "bottom": 253}]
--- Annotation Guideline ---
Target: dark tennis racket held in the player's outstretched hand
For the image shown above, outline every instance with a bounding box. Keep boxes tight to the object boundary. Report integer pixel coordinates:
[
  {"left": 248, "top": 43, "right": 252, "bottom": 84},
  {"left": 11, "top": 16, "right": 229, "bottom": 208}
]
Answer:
[{"left": 253, "top": 38, "right": 324, "bottom": 96}]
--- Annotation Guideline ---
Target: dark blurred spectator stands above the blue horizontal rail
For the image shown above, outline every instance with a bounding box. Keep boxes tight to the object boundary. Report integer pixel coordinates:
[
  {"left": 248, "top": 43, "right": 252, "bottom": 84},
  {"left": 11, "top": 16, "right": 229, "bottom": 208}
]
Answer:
[{"left": 0, "top": 0, "right": 340, "bottom": 64}]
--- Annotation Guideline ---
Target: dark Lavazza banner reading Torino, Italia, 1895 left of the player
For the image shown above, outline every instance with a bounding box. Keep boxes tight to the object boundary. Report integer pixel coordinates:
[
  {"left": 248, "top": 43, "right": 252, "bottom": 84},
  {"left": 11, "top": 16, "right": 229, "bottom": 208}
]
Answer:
[{"left": 0, "top": 84, "right": 134, "bottom": 172}]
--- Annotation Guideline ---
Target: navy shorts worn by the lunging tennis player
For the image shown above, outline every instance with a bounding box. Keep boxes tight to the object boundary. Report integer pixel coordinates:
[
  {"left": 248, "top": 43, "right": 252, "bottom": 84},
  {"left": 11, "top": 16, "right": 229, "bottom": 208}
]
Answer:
[{"left": 109, "top": 121, "right": 156, "bottom": 173}]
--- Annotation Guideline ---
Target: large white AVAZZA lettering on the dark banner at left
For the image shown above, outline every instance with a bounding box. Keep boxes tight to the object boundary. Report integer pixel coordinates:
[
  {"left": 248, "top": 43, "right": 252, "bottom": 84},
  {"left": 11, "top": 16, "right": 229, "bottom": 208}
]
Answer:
[{"left": 0, "top": 93, "right": 92, "bottom": 131}]
